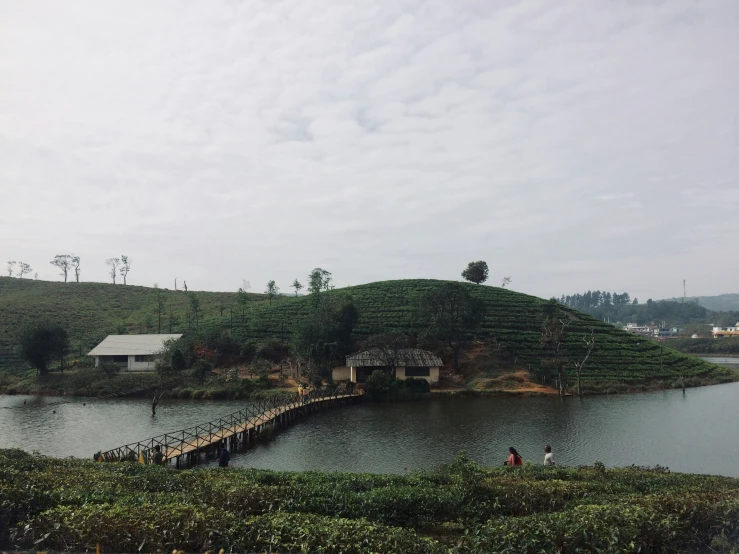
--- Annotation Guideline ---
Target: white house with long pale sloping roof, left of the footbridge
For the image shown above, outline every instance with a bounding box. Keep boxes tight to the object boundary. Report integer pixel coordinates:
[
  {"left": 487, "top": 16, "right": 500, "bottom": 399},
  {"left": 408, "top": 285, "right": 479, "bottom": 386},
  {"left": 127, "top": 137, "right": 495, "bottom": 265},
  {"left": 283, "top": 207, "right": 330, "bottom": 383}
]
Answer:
[{"left": 88, "top": 334, "right": 182, "bottom": 371}]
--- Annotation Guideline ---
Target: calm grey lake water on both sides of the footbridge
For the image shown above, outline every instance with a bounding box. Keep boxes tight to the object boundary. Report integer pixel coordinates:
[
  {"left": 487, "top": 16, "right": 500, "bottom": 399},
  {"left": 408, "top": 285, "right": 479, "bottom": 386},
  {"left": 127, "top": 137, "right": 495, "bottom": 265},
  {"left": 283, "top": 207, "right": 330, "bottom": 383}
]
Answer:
[{"left": 0, "top": 383, "right": 739, "bottom": 477}]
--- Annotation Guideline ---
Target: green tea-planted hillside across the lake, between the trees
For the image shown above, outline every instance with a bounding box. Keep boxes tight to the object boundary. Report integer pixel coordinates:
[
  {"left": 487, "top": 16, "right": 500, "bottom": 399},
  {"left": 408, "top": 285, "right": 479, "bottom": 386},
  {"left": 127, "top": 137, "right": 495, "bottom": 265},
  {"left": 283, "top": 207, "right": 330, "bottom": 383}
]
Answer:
[{"left": 0, "top": 278, "right": 730, "bottom": 390}]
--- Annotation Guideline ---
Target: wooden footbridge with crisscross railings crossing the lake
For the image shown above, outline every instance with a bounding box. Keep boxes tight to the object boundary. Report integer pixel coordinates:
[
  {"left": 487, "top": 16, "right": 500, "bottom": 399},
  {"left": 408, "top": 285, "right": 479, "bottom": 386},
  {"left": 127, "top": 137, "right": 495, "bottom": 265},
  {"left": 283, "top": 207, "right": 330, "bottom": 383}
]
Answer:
[{"left": 95, "top": 387, "right": 361, "bottom": 468}]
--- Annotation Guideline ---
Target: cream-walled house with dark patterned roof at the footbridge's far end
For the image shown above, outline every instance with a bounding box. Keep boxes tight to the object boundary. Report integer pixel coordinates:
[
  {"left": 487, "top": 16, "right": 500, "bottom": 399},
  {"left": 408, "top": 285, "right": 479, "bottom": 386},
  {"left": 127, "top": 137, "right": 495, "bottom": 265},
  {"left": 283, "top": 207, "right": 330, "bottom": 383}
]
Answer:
[{"left": 333, "top": 348, "right": 443, "bottom": 383}]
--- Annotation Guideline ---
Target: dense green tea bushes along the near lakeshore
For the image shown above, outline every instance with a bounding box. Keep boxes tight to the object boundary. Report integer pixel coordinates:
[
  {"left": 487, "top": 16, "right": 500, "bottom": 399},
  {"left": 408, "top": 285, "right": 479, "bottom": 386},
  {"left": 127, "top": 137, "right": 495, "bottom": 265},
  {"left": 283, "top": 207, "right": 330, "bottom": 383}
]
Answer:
[{"left": 0, "top": 450, "right": 739, "bottom": 553}]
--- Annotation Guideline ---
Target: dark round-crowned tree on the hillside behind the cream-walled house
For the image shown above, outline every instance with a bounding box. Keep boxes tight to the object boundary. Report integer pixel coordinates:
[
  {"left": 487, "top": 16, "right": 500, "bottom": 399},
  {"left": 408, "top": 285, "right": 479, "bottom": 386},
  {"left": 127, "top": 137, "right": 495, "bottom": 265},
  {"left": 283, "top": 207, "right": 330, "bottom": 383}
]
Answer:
[{"left": 419, "top": 283, "right": 483, "bottom": 372}]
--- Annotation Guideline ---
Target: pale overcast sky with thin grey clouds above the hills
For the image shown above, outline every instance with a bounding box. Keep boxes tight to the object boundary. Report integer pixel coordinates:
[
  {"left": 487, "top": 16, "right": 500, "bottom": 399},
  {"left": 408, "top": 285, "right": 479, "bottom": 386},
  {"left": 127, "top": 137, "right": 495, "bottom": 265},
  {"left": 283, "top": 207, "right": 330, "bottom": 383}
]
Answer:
[{"left": 0, "top": 0, "right": 739, "bottom": 300}]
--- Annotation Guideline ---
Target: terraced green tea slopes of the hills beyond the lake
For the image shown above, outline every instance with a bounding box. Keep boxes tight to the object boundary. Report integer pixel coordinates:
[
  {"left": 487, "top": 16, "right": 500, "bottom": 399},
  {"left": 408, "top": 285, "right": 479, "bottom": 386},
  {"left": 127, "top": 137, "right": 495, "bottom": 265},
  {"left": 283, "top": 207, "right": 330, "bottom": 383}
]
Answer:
[{"left": 0, "top": 278, "right": 736, "bottom": 394}]
